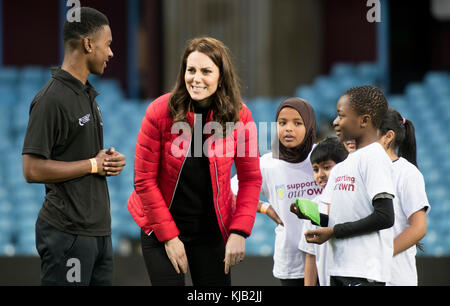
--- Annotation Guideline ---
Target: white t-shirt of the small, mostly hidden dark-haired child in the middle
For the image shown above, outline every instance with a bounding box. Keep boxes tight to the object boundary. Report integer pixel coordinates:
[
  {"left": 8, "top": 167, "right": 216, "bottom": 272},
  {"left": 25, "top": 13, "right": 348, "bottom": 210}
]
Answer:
[{"left": 298, "top": 196, "right": 330, "bottom": 286}]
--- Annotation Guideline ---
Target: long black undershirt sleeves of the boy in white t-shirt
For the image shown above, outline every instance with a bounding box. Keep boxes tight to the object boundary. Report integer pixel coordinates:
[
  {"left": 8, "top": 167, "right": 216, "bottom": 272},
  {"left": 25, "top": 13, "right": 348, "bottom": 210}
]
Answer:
[{"left": 320, "top": 198, "right": 395, "bottom": 238}]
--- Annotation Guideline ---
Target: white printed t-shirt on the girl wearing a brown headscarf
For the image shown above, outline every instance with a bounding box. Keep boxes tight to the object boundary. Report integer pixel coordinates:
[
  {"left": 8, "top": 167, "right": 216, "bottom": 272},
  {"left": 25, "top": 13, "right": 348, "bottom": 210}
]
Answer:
[{"left": 231, "top": 153, "right": 322, "bottom": 279}]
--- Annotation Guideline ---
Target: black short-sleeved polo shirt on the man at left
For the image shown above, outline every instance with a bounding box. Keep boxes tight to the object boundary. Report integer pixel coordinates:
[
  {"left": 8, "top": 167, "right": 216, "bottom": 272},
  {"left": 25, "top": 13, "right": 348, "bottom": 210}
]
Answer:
[{"left": 22, "top": 68, "right": 111, "bottom": 236}]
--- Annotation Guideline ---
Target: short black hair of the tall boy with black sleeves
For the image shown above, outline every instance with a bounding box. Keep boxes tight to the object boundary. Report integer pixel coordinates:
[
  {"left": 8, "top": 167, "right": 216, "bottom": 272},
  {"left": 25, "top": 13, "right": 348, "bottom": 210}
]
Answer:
[{"left": 344, "top": 85, "right": 388, "bottom": 129}]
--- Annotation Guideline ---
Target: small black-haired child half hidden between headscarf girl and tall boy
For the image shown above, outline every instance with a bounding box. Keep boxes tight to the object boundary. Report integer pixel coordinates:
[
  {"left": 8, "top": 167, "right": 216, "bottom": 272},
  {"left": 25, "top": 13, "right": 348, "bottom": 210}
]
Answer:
[{"left": 291, "top": 137, "right": 348, "bottom": 286}]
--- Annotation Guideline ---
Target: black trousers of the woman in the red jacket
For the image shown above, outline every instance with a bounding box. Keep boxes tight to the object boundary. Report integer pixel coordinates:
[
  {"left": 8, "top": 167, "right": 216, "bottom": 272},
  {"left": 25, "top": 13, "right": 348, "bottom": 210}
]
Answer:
[{"left": 141, "top": 231, "right": 231, "bottom": 286}]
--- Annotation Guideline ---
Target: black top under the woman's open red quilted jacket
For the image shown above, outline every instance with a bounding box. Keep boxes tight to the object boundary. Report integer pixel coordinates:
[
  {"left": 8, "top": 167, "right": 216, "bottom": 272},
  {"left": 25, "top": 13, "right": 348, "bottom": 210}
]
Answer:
[{"left": 170, "top": 104, "right": 220, "bottom": 242}]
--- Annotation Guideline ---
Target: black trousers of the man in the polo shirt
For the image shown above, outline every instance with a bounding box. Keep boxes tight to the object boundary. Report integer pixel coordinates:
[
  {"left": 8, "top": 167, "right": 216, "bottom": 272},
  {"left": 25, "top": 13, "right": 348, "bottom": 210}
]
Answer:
[{"left": 36, "top": 218, "right": 114, "bottom": 286}]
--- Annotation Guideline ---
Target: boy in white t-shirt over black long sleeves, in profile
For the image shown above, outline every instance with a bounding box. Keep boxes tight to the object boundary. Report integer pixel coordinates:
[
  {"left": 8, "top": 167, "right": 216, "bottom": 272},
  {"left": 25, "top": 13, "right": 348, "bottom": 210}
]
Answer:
[{"left": 305, "top": 86, "right": 395, "bottom": 286}]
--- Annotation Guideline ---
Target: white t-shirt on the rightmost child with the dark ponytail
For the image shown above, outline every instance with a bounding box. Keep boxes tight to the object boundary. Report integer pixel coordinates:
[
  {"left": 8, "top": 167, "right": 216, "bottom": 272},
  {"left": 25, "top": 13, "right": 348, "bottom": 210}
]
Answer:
[{"left": 387, "top": 157, "right": 430, "bottom": 286}]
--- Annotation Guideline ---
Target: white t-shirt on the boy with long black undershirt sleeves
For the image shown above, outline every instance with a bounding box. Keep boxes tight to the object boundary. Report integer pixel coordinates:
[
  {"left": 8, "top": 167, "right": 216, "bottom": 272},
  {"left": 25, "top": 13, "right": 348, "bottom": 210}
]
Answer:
[{"left": 322, "top": 142, "right": 395, "bottom": 282}]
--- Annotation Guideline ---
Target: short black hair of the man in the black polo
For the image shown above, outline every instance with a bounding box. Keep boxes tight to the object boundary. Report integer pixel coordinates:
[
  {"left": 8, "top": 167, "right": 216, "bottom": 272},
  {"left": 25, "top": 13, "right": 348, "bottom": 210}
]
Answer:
[{"left": 63, "top": 7, "right": 109, "bottom": 48}]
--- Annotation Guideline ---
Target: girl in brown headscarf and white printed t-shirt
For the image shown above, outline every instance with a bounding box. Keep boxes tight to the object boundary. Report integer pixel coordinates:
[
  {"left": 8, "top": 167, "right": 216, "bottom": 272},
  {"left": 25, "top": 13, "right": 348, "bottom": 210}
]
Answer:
[{"left": 232, "top": 98, "right": 316, "bottom": 286}]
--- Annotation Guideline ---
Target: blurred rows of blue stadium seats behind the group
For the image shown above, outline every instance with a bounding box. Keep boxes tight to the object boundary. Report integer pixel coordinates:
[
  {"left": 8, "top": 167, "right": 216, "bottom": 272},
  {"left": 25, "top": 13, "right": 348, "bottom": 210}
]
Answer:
[{"left": 0, "top": 63, "right": 450, "bottom": 256}]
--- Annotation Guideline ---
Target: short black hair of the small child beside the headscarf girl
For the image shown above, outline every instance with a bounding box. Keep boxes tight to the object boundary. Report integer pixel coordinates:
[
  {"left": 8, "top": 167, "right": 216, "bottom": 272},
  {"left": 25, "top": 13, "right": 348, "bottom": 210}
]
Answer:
[{"left": 309, "top": 137, "right": 348, "bottom": 164}]
